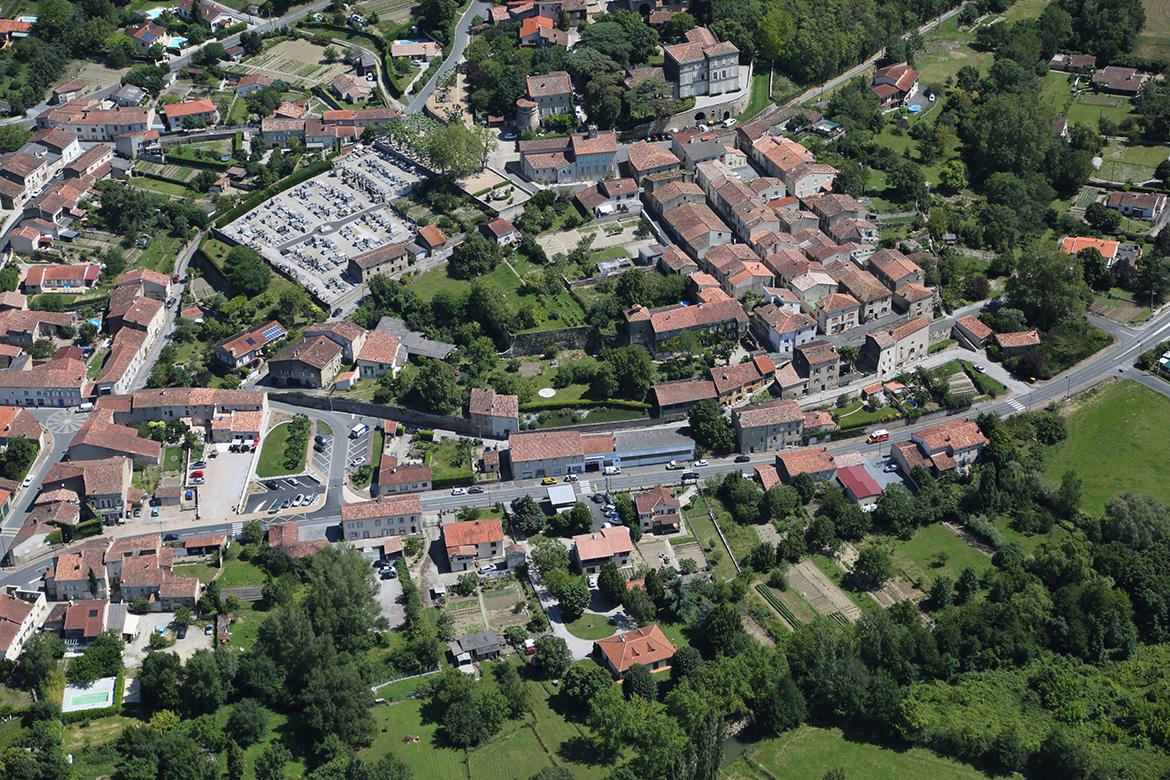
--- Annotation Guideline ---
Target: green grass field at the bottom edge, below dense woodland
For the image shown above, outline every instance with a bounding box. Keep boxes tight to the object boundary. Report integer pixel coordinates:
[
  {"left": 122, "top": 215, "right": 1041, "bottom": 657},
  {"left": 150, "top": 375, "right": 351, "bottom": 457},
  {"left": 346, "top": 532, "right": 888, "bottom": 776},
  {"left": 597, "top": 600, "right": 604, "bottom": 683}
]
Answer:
[{"left": 721, "top": 726, "right": 987, "bottom": 780}]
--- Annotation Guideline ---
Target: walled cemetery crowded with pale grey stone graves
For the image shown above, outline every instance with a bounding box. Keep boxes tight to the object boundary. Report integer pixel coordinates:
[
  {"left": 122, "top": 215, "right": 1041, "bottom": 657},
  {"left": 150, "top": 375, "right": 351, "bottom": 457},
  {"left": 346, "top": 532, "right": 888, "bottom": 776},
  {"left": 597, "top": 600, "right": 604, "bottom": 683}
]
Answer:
[{"left": 223, "top": 146, "right": 419, "bottom": 304}]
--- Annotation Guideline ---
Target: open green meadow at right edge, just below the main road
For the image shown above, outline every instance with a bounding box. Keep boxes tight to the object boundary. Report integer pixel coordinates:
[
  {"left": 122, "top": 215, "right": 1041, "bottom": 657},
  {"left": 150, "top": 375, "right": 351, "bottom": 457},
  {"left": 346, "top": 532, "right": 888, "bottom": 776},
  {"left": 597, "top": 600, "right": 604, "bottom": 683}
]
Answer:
[{"left": 1045, "top": 380, "right": 1170, "bottom": 513}]
